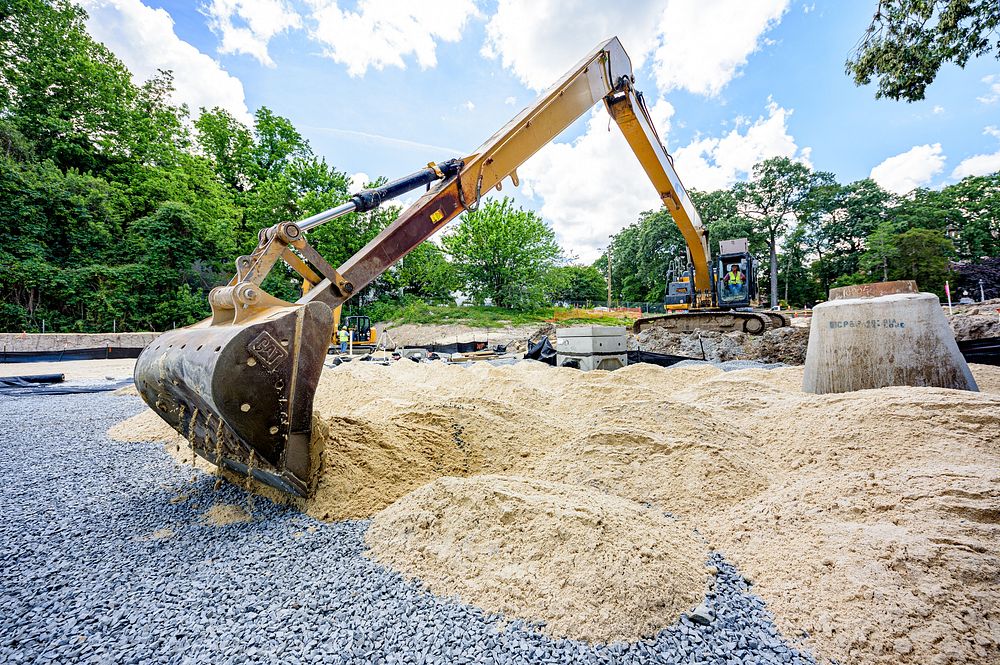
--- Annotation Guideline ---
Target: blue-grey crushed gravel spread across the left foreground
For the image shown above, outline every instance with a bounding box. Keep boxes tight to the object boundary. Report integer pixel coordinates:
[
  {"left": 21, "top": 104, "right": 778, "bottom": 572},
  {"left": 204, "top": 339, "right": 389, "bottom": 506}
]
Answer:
[{"left": 0, "top": 394, "right": 815, "bottom": 665}]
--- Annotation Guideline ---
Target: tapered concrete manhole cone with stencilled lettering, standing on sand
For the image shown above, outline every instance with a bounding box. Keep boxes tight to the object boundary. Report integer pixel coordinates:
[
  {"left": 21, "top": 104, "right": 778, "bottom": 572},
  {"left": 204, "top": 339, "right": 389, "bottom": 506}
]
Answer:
[{"left": 802, "top": 281, "right": 979, "bottom": 394}]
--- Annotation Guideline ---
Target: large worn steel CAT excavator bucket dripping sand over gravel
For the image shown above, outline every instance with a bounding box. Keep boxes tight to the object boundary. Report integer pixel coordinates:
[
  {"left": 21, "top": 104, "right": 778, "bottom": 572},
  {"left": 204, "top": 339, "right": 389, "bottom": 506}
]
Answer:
[{"left": 135, "top": 302, "right": 333, "bottom": 497}]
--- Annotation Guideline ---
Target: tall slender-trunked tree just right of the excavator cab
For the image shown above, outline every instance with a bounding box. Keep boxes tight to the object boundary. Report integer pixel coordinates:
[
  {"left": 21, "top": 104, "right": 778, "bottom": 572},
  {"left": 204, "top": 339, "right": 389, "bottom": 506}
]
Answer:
[{"left": 733, "top": 157, "right": 811, "bottom": 307}]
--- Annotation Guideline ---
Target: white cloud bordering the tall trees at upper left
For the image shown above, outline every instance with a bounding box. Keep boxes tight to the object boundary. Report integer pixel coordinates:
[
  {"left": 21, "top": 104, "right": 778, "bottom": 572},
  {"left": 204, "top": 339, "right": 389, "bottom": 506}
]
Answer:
[{"left": 82, "top": 0, "right": 252, "bottom": 123}]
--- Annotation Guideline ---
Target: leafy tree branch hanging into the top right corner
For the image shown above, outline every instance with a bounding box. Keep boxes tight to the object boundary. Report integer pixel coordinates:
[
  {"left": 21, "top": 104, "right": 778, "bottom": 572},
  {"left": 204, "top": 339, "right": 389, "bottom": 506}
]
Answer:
[{"left": 846, "top": 0, "right": 1000, "bottom": 102}]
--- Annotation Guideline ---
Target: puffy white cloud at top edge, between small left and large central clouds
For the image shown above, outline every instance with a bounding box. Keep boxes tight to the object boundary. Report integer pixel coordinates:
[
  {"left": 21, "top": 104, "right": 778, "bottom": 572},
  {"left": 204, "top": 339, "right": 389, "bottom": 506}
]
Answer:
[{"left": 307, "top": 0, "right": 479, "bottom": 76}]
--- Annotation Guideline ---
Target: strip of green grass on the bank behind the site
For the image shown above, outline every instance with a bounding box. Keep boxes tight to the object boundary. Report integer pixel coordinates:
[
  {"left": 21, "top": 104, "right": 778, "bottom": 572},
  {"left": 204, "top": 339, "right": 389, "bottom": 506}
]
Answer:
[{"left": 373, "top": 301, "right": 635, "bottom": 328}]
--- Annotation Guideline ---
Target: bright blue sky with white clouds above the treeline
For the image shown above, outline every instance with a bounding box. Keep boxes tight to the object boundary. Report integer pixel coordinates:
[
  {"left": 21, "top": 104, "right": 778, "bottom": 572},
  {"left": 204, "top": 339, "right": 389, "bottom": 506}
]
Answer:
[{"left": 84, "top": 0, "right": 1000, "bottom": 260}]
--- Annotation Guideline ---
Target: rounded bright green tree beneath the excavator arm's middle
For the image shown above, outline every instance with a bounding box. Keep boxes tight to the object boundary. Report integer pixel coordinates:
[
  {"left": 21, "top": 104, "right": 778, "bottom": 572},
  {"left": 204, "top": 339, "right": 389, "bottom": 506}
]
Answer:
[{"left": 442, "top": 197, "right": 562, "bottom": 307}]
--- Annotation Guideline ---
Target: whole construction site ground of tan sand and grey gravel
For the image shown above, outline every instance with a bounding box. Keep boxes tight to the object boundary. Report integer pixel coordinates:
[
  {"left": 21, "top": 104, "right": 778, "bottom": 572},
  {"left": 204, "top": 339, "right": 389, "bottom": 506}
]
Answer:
[{"left": 0, "top": 342, "right": 1000, "bottom": 664}]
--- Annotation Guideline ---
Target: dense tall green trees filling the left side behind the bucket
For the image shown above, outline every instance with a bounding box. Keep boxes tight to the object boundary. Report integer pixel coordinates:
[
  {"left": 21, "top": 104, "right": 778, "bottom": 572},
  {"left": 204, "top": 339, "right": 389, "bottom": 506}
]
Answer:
[{"left": 0, "top": 0, "right": 390, "bottom": 332}]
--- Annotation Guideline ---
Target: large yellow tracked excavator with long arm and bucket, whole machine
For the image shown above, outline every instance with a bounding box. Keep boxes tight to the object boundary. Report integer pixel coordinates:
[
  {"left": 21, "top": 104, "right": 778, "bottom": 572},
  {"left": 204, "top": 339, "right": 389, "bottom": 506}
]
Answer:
[{"left": 135, "top": 38, "right": 788, "bottom": 497}]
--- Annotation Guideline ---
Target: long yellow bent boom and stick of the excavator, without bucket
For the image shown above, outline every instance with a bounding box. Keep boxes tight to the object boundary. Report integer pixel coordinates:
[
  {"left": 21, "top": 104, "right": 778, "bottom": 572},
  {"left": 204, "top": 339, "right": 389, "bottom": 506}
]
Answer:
[{"left": 305, "top": 37, "right": 712, "bottom": 306}]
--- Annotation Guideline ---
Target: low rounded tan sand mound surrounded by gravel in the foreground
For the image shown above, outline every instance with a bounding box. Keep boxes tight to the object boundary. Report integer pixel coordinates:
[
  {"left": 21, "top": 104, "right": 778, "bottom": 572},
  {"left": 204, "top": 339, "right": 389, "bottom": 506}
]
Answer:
[{"left": 366, "top": 476, "right": 708, "bottom": 642}]
